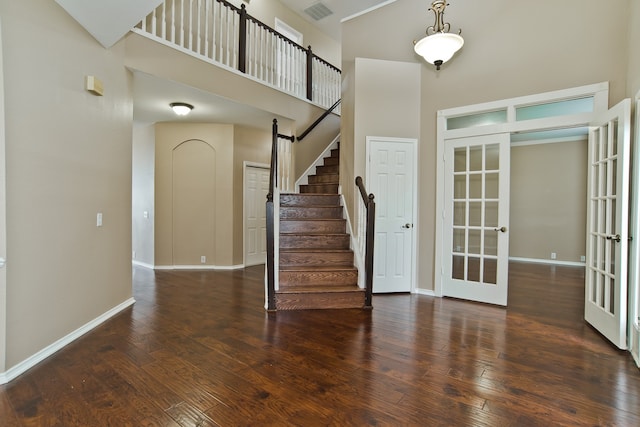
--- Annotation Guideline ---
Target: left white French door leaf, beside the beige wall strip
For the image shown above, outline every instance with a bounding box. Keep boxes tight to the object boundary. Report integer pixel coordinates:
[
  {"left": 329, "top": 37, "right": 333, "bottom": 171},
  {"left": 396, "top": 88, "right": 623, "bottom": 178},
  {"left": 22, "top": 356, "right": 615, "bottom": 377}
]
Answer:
[{"left": 442, "top": 134, "right": 510, "bottom": 305}]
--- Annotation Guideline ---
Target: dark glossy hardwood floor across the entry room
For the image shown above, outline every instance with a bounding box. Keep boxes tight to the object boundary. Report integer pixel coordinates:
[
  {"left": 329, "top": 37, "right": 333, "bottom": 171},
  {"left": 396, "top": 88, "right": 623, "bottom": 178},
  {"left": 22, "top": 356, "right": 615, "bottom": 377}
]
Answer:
[{"left": 0, "top": 264, "right": 640, "bottom": 426}]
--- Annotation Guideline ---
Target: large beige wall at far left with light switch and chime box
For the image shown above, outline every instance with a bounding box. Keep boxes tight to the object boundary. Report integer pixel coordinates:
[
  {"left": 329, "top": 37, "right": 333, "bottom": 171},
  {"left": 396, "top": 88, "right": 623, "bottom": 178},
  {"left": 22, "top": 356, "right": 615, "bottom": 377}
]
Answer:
[{"left": 0, "top": 0, "right": 133, "bottom": 368}]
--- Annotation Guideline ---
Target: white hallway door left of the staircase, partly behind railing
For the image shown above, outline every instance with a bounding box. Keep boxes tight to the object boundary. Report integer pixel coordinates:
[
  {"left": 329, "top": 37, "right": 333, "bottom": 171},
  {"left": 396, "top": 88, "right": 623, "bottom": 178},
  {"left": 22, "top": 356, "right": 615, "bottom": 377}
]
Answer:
[{"left": 244, "top": 166, "right": 269, "bottom": 267}]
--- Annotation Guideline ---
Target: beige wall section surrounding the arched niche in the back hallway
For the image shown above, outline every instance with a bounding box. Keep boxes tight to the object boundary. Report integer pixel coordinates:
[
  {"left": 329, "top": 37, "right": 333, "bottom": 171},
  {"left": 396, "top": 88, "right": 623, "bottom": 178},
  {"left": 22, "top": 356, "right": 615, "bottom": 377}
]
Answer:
[{"left": 155, "top": 123, "right": 234, "bottom": 266}]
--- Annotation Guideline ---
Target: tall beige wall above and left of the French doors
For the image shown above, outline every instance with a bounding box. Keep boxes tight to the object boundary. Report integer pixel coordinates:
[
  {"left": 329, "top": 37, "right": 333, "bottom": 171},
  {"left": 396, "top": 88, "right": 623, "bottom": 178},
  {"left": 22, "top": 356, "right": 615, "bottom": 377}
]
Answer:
[{"left": 342, "top": 0, "right": 637, "bottom": 290}]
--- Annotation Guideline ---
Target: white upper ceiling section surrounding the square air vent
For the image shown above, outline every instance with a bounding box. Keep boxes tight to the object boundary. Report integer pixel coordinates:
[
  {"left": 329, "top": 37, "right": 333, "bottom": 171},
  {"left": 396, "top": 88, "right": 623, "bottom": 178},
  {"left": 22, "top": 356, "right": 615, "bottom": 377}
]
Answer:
[{"left": 280, "top": 0, "right": 389, "bottom": 41}]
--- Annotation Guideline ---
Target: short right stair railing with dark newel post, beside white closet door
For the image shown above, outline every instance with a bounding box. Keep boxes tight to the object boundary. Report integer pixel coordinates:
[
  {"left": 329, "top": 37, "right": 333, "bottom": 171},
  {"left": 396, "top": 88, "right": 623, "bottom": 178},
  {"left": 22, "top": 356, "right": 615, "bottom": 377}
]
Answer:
[{"left": 356, "top": 176, "right": 376, "bottom": 309}]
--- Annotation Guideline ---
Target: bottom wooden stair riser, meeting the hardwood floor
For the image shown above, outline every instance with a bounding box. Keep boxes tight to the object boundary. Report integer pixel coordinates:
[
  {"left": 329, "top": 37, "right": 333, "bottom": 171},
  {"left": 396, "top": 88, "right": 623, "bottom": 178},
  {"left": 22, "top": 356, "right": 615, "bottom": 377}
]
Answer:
[{"left": 276, "top": 291, "right": 364, "bottom": 310}]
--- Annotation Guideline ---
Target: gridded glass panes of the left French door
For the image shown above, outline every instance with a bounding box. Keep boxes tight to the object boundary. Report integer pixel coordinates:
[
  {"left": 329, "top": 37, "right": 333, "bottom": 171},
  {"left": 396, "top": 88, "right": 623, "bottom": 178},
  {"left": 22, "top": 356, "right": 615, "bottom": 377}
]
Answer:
[{"left": 451, "top": 144, "right": 500, "bottom": 285}]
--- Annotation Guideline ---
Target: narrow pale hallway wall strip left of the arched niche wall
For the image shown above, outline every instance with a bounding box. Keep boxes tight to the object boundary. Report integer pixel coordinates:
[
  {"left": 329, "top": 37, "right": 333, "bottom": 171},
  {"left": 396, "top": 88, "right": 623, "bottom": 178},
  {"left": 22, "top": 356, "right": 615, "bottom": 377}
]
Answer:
[{"left": 131, "top": 123, "right": 155, "bottom": 266}]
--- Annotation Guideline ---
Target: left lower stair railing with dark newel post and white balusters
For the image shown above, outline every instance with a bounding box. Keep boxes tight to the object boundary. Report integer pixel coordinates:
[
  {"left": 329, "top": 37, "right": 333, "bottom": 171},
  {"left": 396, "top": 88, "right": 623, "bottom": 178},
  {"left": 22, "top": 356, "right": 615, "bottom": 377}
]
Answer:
[{"left": 266, "top": 119, "right": 295, "bottom": 311}]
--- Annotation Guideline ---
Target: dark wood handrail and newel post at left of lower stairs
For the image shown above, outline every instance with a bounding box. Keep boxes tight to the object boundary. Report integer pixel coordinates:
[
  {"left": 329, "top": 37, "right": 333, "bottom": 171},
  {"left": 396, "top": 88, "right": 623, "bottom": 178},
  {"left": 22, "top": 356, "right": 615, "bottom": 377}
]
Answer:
[{"left": 266, "top": 119, "right": 295, "bottom": 311}]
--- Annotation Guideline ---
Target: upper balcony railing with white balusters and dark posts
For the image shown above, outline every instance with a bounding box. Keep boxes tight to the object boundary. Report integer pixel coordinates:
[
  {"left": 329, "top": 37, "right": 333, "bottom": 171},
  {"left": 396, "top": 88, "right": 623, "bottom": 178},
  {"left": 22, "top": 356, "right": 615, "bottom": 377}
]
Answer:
[{"left": 133, "top": 0, "right": 341, "bottom": 112}]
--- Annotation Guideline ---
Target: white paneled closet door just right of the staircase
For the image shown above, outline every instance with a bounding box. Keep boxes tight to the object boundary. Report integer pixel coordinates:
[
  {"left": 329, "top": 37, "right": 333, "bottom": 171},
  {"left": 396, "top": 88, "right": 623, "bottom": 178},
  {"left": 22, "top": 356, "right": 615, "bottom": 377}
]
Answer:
[{"left": 367, "top": 138, "right": 416, "bottom": 293}]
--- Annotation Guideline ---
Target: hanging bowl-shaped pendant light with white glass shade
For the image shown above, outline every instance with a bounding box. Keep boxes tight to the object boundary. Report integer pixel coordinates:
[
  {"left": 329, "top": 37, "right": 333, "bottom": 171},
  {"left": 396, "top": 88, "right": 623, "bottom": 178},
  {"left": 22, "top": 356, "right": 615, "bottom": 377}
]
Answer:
[{"left": 413, "top": 0, "right": 464, "bottom": 70}]
